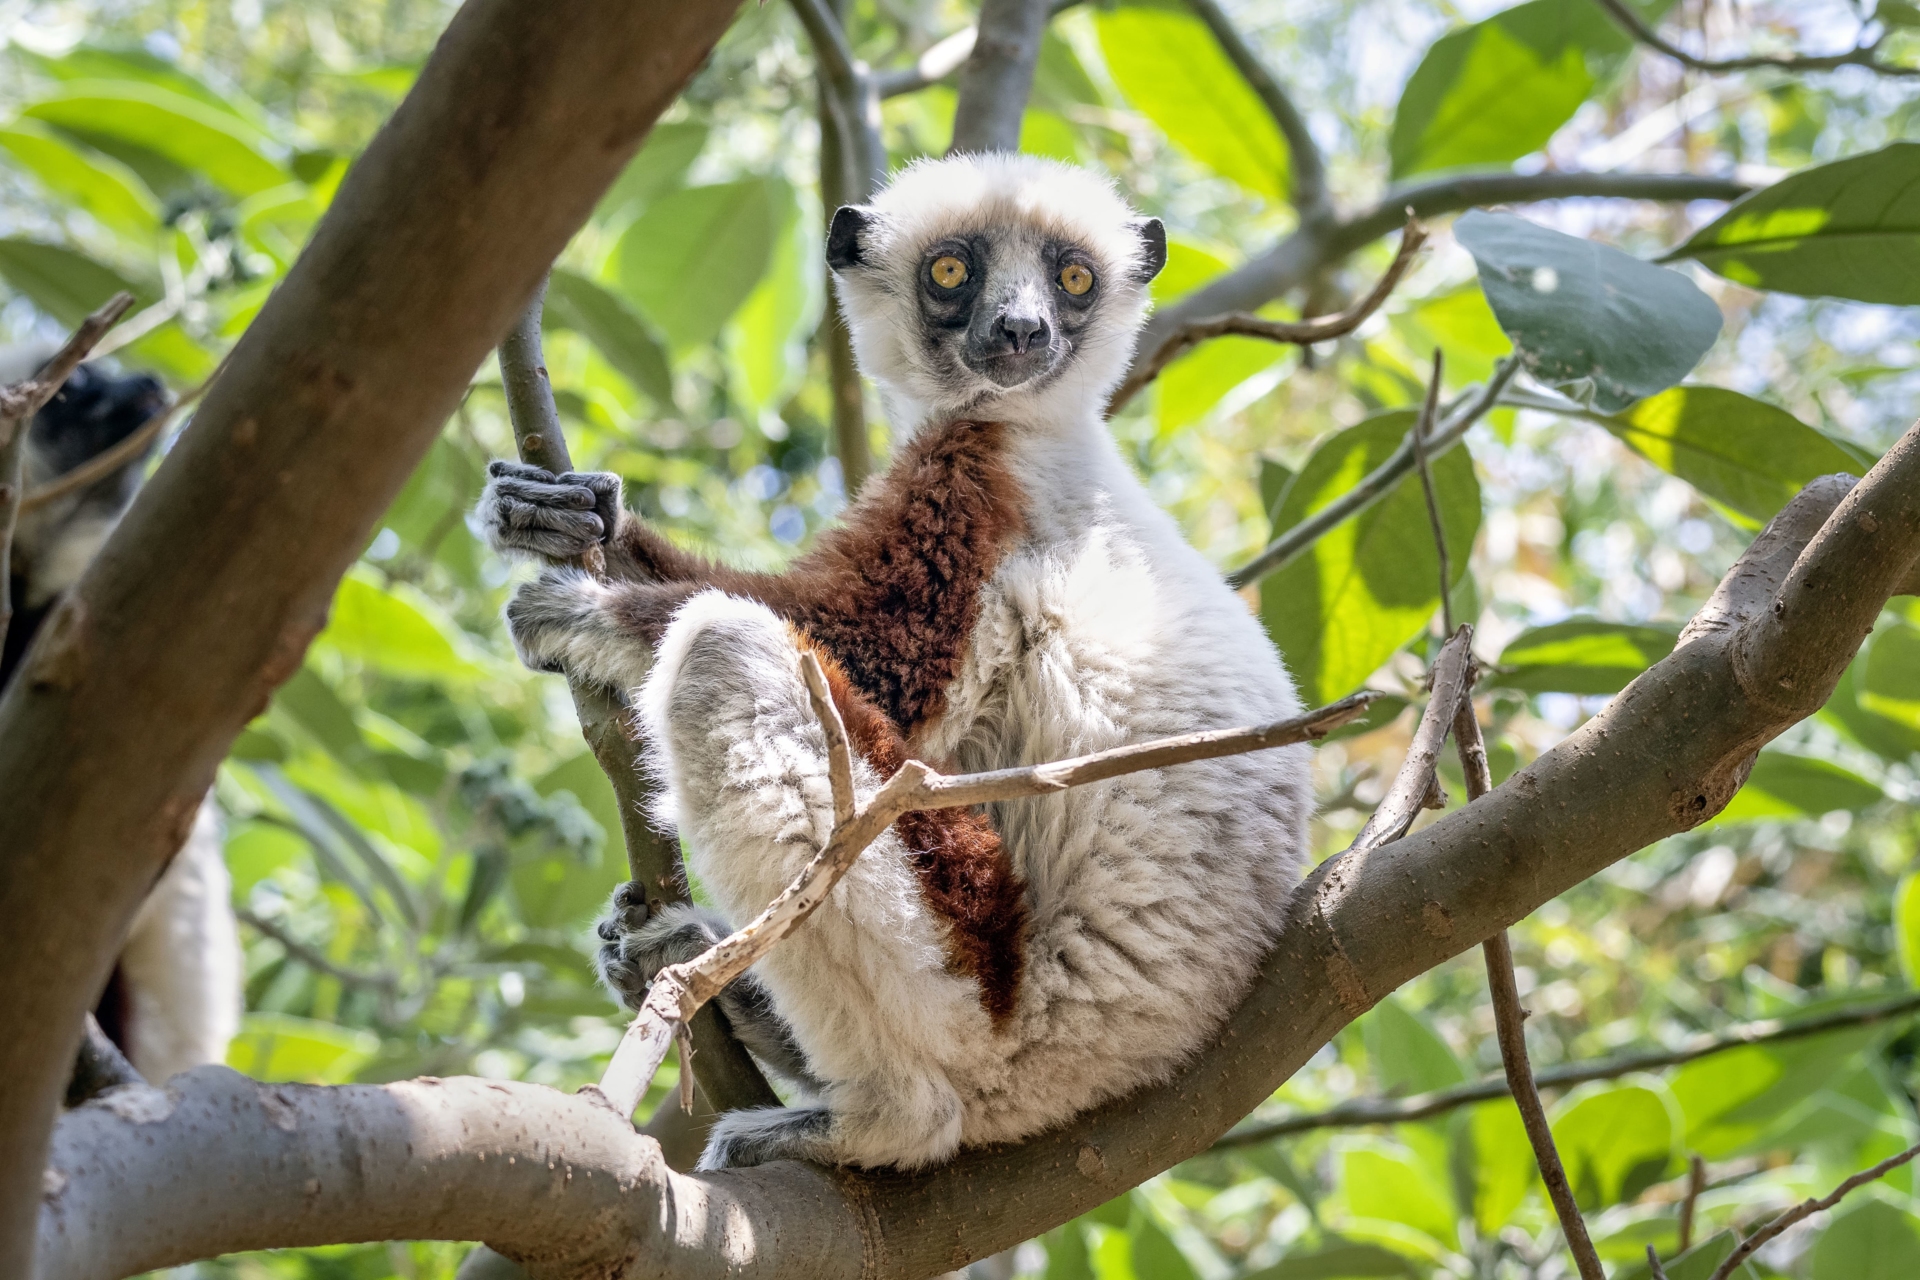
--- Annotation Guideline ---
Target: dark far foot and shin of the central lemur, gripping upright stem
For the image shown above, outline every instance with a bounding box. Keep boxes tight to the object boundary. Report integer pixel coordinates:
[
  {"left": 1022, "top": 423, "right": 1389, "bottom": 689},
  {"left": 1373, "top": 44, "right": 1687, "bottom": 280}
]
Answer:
[{"left": 595, "top": 881, "right": 820, "bottom": 1090}]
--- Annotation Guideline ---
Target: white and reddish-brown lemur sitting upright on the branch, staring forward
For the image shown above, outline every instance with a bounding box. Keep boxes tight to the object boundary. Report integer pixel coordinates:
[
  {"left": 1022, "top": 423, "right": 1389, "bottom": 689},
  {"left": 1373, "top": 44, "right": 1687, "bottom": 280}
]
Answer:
[{"left": 480, "top": 155, "right": 1313, "bottom": 1169}]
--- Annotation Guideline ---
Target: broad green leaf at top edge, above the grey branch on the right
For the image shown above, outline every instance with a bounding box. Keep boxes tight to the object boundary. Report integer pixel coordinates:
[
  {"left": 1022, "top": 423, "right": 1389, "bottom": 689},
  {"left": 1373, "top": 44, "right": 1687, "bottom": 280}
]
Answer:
[{"left": 1388, "top": 0, "right": 1632, "bottom": 178}]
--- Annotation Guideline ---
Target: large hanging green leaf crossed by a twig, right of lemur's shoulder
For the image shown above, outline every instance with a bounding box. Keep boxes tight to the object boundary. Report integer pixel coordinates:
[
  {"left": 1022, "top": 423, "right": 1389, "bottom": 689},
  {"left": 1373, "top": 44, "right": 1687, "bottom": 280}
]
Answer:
[{"left": 1260, "top": 409, "right": 1480, "bottom": 704}]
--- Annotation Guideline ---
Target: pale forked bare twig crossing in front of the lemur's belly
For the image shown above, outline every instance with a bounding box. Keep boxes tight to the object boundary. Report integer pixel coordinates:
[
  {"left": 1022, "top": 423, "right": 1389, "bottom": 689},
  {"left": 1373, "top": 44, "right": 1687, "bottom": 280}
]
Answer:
[{"left": 599, "top": 694, "right": 1373, "bottom": 1115}]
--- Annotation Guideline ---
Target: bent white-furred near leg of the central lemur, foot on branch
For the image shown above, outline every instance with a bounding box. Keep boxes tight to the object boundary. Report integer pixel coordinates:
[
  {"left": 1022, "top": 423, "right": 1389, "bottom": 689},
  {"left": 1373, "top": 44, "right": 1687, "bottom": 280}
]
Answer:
[{"left": 639, "top": 591, "right": 989, "bottom": 1167}]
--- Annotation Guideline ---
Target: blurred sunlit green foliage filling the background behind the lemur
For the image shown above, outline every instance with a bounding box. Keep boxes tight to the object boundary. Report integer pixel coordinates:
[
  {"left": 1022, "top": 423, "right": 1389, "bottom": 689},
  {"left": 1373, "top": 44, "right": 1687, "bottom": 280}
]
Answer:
[{"left": 11, "top": 0, "right": 1920, "bottom": 1280}]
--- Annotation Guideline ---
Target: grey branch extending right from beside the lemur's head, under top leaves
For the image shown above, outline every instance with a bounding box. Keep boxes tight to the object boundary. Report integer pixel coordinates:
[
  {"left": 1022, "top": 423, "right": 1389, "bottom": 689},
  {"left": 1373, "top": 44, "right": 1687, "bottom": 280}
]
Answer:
[{"left": 1139, "top": 173, "right": 1751, "bottom": 370}]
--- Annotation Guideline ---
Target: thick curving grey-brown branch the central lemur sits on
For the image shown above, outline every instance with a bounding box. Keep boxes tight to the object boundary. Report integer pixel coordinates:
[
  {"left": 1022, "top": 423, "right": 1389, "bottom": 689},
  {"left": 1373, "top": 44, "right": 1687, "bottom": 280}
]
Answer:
[{"left": 38, "top": 449, "right": 1920, "bottom": 1280}]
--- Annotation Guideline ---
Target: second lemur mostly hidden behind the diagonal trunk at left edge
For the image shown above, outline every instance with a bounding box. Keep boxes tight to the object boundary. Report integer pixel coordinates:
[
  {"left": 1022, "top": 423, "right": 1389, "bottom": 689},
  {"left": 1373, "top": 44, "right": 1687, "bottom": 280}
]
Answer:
[{"left": 0, "top": 347, "right": 242, "bottom": 1082}]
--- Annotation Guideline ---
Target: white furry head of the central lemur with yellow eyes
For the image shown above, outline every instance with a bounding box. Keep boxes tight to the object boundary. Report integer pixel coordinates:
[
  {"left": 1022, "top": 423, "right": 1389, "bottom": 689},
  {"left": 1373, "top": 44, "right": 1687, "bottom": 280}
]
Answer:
[{"left": 828, "top": 155, "right": 1167, "bottom": 430}]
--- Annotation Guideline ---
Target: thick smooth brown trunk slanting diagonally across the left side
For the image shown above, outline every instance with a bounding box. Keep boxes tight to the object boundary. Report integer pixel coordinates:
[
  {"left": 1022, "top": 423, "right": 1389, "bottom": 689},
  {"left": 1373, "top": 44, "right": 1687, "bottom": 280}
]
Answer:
[{"left": 0, "top": 0, "right": 735, "bottom": 1276}]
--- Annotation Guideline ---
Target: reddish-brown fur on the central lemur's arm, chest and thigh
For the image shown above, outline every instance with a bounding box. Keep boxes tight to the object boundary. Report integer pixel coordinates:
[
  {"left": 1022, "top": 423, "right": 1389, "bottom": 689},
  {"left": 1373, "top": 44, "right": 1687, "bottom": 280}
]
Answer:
[{"left": 609, "top": 422, "right": 1027, "bottom": 1027}]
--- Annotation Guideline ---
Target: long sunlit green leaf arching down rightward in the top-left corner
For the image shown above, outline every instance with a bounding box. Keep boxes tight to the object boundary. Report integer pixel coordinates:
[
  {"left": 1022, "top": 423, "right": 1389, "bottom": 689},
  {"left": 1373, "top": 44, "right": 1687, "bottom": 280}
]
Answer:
[{"left": 21, "top": 81, "right": 292, "bottom": 196}]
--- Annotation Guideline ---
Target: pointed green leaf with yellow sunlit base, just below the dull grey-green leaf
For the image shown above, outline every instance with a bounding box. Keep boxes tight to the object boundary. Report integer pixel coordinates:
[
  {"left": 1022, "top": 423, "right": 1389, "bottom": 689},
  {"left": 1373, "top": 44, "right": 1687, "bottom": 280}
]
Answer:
[{"left": 1601, "top": 386, "right": 1860, "bottom": 524}]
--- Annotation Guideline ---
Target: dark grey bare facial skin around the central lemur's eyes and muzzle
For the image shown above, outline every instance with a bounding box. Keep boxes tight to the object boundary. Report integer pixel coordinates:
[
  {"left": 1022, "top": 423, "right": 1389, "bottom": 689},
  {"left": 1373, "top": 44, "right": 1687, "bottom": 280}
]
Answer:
[{"left": 920, "top": 236, "right": 1100, "bottom": 388}]
